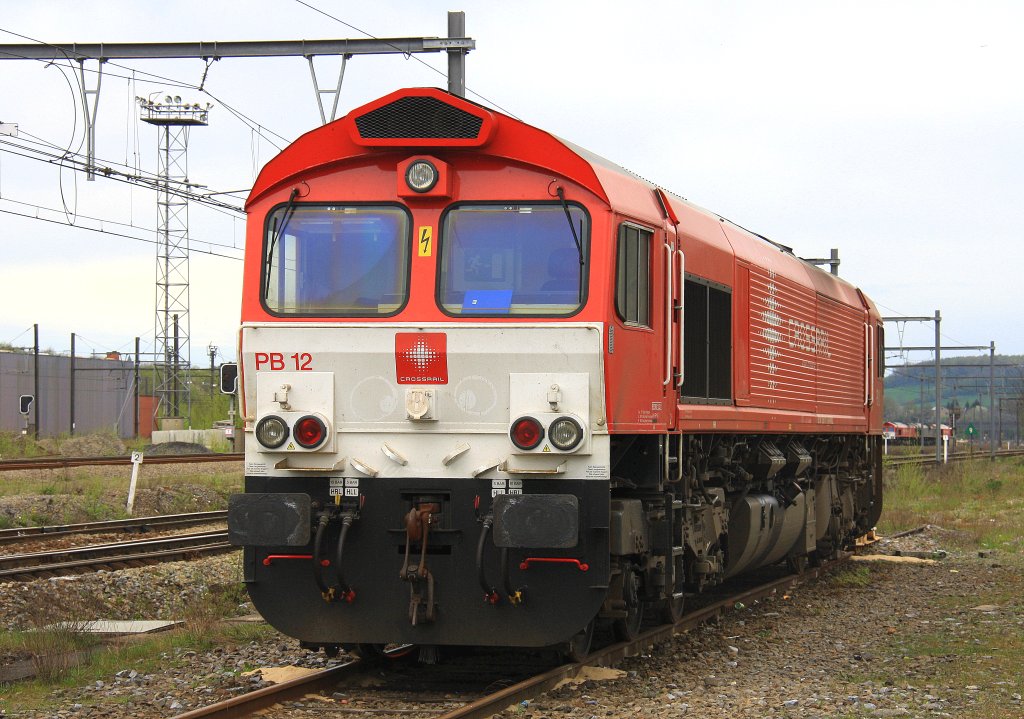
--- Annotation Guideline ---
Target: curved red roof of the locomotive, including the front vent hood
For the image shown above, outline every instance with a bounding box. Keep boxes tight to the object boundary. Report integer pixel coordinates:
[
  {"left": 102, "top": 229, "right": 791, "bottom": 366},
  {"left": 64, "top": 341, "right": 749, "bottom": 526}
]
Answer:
[{"left": 247, "top": 88, "right": 871, "bottom": 308}]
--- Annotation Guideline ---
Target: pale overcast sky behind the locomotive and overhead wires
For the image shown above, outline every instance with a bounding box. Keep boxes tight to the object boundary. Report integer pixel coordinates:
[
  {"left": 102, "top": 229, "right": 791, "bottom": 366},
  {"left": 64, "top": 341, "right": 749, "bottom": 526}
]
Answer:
[{"left": 0, "top": 0, "right": 1024, "bottom": 365}]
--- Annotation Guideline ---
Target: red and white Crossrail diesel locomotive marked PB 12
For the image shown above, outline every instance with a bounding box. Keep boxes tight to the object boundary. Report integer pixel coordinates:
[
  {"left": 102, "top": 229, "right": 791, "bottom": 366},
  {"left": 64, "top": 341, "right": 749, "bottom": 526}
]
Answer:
[{"left": 228, "top": 89, "right": 883, "bottom": 655}]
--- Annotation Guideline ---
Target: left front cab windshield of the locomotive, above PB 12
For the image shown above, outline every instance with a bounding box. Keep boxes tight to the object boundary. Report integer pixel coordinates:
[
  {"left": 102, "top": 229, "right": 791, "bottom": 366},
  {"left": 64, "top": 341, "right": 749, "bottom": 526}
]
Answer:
[{"left": 263, "top": 205, "right": 411, "bottom": 316}]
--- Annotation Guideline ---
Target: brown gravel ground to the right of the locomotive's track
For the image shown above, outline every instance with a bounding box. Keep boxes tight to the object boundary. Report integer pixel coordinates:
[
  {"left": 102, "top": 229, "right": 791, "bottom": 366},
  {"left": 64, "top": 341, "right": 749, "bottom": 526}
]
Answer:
[{"left": 503, "top": 530, "right": 1024, "bottom": 719}]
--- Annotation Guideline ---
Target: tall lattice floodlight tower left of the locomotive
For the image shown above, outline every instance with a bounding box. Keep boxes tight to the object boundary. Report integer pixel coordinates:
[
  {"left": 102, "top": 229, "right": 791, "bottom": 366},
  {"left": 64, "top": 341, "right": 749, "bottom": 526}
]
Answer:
[{"left": 135, "top": 95, "right": 211, "bottom": 417}]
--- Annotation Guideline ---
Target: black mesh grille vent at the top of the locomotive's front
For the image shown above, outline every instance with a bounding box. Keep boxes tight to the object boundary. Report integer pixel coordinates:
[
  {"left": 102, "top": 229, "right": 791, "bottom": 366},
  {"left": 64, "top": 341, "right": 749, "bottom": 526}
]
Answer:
[{"left": 355, "top": 97, "right": 483, "bottom": 139}]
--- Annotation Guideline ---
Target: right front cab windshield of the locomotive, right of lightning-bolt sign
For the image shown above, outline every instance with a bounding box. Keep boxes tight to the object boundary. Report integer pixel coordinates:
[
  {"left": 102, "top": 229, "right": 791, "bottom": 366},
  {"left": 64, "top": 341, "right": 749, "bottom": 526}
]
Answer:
[{"left": 438, "top": 204, "right": 590, "bottom": 316}]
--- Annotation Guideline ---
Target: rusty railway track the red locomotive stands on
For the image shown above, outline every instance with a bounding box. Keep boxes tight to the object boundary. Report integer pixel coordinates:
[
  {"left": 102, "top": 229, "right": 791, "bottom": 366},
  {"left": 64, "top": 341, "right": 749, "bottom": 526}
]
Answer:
[{"left": 167, "top": 559, "right": 842, "bottom": 719}]
